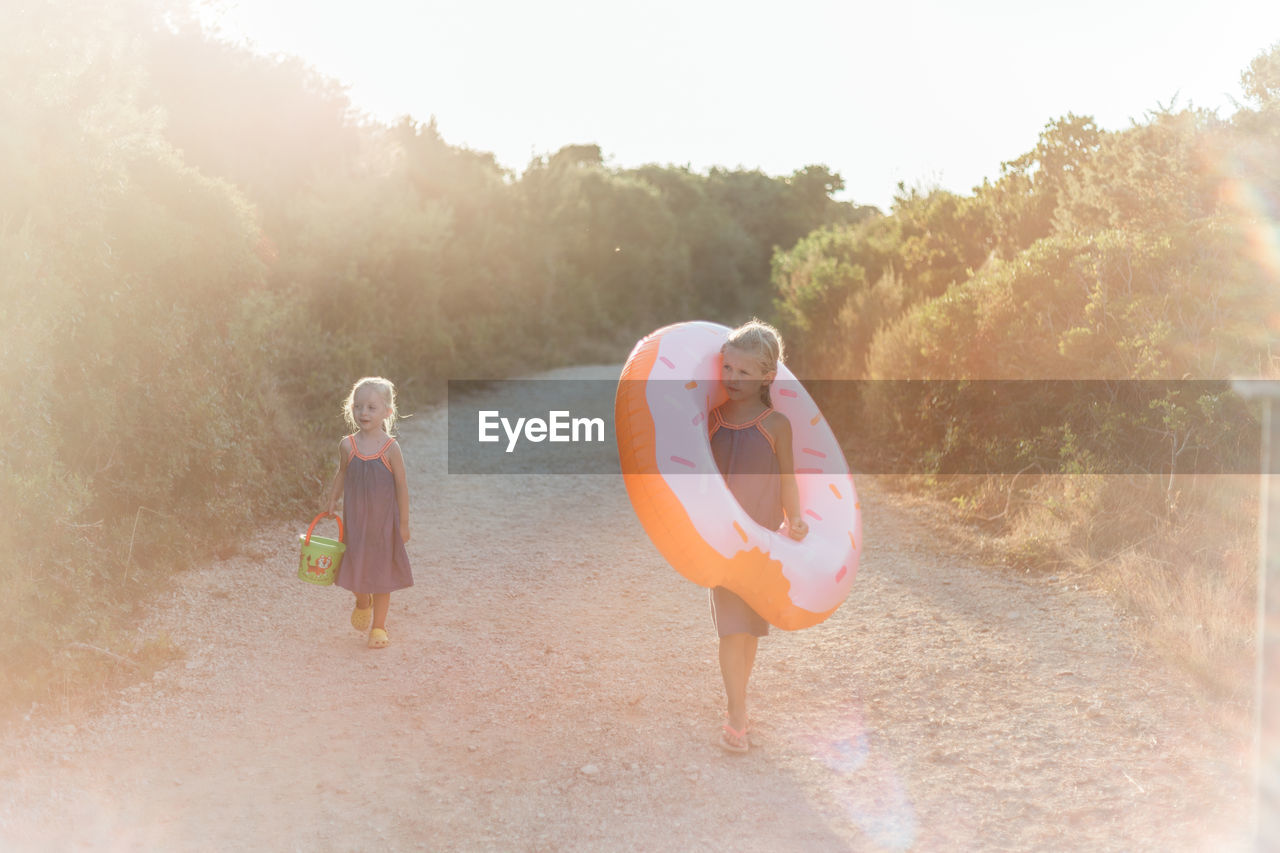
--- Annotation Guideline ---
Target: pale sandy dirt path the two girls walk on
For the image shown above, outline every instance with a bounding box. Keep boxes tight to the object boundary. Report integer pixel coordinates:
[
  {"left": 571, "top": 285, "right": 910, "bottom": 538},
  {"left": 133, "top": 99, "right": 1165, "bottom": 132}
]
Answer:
[{"left": 0, "top": 368, "right": 1249, "bottom": 850}]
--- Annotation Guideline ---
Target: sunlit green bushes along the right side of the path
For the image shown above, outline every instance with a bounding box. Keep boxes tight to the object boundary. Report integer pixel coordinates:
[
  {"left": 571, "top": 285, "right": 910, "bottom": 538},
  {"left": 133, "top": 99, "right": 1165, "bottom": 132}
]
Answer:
[{"left": 773, "top": 39, "right": 1280, "bottom": 691}]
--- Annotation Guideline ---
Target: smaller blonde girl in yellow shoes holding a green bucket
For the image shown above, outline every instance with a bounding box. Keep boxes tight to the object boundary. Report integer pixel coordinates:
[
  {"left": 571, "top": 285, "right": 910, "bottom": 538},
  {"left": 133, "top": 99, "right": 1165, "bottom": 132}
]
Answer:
[{"left": 328, "top": 377, "right": 413, "bottom": 648}]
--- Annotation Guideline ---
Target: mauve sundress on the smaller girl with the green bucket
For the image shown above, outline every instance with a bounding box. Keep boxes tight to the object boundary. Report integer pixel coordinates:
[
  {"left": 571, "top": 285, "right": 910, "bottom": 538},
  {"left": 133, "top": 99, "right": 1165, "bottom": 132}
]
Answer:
[{"left": 337, "top": 435, "right": 413, "bottom": 593}]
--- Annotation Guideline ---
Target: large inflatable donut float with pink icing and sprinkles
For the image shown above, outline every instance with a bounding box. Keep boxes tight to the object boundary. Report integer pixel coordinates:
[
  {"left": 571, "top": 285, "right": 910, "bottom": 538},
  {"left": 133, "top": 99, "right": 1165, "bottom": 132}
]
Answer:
[{"left": 613, "top": 323, "right": 863, "bottom": 630}]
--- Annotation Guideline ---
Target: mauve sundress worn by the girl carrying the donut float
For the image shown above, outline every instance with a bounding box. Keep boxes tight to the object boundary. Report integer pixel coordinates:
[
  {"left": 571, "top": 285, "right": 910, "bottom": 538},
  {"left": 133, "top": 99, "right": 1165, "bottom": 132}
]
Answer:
[{"left": 708, "top": 407, "right": 783, "bottom": 637}]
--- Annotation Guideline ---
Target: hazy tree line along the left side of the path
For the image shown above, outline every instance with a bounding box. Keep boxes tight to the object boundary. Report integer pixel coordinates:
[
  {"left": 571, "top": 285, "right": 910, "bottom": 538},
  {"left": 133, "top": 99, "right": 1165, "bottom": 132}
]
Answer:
[{"left": 0, "top": 0, "right": 874, "bottom": 699}]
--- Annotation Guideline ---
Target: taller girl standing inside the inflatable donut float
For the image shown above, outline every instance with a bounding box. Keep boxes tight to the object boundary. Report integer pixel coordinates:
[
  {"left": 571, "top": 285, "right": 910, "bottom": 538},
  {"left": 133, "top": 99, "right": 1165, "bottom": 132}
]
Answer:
[{"left": 711, "top": 320, "right": 809, "bottom": 752}]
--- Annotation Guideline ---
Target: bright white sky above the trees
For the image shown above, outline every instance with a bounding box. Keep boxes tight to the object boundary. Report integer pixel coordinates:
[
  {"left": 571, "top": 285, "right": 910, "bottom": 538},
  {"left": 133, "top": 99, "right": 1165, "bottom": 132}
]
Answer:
[{"left": 204, "top": 0, "right": 1280, "bottom": 210}]
